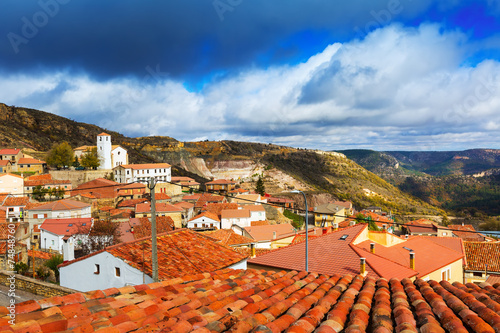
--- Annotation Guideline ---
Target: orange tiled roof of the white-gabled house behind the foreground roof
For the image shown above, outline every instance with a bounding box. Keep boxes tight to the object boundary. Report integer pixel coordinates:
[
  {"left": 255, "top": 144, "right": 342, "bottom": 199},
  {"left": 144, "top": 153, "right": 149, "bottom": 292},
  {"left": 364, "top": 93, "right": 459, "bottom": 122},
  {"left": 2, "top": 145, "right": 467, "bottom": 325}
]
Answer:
[{"left": 61, "top": 229, "right": 245, "bottom": 280}]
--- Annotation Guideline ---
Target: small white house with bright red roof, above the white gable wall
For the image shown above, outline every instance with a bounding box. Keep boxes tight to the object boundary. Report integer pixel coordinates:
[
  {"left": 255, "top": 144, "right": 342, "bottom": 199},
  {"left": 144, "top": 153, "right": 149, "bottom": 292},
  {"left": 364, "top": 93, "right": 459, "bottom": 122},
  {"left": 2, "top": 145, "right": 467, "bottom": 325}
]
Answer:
[{"left": 40, "top": 217, "right": 94, "bottom": 253}]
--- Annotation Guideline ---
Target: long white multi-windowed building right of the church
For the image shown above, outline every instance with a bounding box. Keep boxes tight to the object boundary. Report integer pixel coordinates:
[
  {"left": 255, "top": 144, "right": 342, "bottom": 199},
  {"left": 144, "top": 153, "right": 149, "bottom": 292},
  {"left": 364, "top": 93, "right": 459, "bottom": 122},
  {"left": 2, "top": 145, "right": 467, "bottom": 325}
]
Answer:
[{"left": 113, "top": 163, "right": 172, "bottom": 184}]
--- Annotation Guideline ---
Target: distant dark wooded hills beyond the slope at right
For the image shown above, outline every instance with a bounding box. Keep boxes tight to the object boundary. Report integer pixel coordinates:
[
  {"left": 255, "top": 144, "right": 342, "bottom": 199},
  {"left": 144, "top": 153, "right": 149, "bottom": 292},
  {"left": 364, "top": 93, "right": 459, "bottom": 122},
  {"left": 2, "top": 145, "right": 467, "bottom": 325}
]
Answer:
[{"left": 342, "top": 149, "right": 500, "bottom": 216}]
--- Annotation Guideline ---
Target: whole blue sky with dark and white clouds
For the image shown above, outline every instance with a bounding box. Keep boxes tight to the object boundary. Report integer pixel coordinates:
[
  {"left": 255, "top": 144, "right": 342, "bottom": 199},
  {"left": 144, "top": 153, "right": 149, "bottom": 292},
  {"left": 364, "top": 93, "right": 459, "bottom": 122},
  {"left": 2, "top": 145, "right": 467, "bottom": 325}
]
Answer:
[{"left": 0, "top": 0, "right": 500, "bottom": 151}]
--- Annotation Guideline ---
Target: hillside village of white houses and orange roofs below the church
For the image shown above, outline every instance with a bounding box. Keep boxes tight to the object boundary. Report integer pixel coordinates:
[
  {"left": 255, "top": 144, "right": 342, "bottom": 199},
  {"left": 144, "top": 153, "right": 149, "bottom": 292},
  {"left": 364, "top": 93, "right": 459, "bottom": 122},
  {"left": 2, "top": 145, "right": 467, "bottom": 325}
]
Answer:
[{"left": 0, "top": 133, "right": 500, "bottom": 331}]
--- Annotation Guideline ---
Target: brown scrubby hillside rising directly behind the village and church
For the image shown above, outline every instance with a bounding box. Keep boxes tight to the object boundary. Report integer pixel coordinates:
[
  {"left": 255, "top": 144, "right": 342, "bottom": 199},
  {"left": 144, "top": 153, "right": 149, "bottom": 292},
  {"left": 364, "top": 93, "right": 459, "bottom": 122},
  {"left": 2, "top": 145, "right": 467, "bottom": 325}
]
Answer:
[{"left": 0, "top": 104, "right": 446, "bottom": 214}]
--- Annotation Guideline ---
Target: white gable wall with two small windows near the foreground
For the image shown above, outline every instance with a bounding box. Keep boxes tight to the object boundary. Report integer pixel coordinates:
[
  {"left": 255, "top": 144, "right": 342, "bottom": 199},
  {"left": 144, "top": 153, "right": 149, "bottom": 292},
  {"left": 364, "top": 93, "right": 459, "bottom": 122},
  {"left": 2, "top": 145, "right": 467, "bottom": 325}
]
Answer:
[{"left": 59, "top": 252, "right": 153, "bottom": 291}]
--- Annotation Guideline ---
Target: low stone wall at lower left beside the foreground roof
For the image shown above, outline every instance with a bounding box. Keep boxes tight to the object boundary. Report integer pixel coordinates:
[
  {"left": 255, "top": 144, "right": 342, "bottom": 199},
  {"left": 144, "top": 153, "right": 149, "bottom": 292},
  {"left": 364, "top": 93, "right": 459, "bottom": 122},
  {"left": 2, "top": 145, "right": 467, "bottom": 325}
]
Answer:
[{"left": 0, "top": 270, "right": 78, "bottom": 297}]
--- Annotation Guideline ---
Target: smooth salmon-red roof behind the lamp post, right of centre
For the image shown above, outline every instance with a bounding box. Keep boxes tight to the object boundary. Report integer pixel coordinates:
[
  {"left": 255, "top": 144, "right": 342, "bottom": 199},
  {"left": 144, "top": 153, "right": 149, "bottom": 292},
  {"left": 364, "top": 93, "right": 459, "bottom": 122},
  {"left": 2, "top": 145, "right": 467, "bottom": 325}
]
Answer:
[{"left": 248, "top": 224, "right": 417, "bottom": 278}]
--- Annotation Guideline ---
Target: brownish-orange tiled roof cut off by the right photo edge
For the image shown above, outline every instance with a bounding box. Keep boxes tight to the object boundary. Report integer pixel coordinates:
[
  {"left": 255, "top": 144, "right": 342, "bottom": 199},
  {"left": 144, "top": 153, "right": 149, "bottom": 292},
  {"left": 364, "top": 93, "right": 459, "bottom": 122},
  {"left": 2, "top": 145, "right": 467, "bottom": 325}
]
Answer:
[{"left": 464, "top": 241, "right": 500, "bottom": 273}]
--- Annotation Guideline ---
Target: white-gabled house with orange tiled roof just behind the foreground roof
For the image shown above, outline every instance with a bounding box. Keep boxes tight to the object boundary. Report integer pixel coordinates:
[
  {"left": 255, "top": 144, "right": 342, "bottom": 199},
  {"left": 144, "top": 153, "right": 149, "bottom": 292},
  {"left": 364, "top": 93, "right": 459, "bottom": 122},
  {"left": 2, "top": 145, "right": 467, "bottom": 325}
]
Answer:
[{"left": 59, "top": 229, "right": 247, "bottom": 291}]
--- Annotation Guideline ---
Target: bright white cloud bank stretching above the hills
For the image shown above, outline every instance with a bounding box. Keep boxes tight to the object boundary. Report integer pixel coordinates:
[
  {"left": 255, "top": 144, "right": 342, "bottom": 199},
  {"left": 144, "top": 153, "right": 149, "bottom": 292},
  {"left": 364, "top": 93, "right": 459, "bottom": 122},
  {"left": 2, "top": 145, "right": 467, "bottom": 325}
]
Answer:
[{"left": 0, "top": 25, "right": 500, "bottom": 150}]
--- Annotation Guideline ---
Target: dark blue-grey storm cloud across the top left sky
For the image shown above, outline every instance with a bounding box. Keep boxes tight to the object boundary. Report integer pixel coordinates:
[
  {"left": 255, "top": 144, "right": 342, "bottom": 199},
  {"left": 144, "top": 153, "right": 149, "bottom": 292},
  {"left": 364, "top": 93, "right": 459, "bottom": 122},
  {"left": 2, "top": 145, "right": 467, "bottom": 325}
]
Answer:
[{"left": 0, "top": 0, "right": 434, "bottom": 79}]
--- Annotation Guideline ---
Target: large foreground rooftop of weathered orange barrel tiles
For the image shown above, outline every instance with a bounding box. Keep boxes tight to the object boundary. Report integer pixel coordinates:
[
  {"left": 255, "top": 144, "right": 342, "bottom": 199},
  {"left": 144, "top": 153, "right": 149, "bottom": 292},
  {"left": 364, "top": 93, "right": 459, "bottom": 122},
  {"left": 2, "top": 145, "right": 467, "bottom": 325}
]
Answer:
[{"left": 5, "top": 269, "right": 500, "bottom": 333}]
